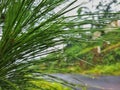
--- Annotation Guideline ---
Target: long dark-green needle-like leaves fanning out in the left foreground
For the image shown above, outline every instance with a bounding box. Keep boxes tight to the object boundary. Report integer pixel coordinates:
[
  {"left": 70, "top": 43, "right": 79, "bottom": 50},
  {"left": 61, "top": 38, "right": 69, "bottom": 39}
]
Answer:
[{"left": 0, "top": 0, "right": 84, "bottom": 90}]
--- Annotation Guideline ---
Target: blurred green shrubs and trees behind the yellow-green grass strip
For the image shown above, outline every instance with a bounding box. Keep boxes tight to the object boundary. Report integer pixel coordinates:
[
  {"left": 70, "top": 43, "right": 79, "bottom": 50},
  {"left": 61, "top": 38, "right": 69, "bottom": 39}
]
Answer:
[{"left": 39, "top": 0, "right": 120, "bottom": 72}]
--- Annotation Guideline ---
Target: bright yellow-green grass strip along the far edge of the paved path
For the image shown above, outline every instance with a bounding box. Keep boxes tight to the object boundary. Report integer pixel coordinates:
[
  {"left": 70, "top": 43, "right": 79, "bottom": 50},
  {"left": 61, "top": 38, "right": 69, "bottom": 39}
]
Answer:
[{"left": 37, "top": 62, "right": 120, "bottom": 76}]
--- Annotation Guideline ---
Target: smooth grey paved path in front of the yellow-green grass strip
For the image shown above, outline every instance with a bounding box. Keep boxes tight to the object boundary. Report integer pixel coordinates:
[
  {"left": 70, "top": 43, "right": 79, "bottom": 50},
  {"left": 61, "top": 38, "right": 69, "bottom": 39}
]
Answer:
[{"left": 53, "top": 74, "right": 120, "bottom": 90}]
